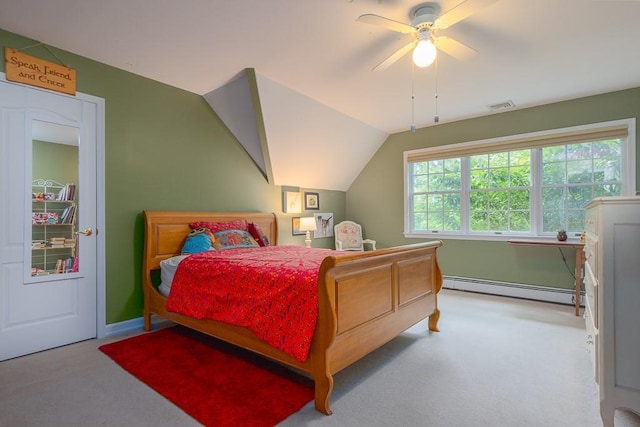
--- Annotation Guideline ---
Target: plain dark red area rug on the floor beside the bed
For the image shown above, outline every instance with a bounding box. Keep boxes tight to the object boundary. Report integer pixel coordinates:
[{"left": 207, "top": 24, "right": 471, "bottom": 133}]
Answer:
[{"left": 100, "top": 326, "right": 313, "bottom": 427}]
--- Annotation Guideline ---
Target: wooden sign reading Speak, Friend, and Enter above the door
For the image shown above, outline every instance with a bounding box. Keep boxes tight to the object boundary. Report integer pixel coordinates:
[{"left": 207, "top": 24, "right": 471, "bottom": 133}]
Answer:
[{"left": 4, "top": 47, "right": 76, "bottom": 95}]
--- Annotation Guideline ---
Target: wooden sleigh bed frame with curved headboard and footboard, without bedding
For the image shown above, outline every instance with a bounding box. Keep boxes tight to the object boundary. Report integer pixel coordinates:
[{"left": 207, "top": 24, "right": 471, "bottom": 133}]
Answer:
[{"left": 142, "top": 211, "right": 442, "bottom": 415}]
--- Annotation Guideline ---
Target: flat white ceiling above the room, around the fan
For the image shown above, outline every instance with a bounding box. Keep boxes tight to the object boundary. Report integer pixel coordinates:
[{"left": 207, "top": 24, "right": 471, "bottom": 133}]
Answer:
[{"left": 0, "top": 0, "right": 640, "bottom": 189}]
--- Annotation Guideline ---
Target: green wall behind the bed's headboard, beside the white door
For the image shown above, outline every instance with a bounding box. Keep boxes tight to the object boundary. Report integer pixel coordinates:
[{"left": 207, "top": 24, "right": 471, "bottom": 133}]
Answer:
[{"left": 0, "top": 29, "right": 346, "bottom": 324}]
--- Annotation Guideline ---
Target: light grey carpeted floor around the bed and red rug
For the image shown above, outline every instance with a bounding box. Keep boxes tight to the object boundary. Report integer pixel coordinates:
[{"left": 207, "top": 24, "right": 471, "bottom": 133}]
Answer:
[{"left": 0, "top": 290, "right": 640, "bottom": 427}]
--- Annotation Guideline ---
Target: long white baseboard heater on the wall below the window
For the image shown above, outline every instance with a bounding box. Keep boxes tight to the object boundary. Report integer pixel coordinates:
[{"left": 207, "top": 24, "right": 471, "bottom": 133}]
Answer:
[{"left": 442, "top": 276, "right": 584, "bottom": 305}]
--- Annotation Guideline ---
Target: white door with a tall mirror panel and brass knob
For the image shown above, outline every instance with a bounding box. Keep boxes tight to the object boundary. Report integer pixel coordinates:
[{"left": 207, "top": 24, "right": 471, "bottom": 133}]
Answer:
[{"left": 0, "top": 77, "right": 103, "bottom": 360}]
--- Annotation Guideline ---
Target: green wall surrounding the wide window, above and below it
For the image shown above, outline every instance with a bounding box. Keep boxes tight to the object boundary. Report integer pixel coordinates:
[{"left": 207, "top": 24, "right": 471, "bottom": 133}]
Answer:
[{"left": 347, "top": 88, "right": 640, "bottom": 288}]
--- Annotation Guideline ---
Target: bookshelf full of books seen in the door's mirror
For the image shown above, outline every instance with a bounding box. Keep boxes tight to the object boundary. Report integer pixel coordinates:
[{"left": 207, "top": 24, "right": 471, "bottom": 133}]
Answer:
[{"left": 31, "top": 179, "right": 77, "bottom": 276}]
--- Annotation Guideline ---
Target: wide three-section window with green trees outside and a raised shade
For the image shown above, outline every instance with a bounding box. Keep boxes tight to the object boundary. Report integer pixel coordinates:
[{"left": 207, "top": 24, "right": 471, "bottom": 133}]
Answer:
[{"left": 405, "top": 120, "right": 635, "bottom": 238}]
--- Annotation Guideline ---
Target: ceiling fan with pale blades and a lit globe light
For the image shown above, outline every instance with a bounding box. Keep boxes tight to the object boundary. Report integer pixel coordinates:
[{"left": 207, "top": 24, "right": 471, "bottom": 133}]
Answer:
[{"left": 358, "top": 0, "right": 498, "bottom": 71}]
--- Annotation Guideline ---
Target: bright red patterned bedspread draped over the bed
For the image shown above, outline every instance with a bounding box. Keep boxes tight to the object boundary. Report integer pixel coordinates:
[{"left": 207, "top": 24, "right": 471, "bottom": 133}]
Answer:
[{"left": 167, "top": 246, "right": 339, "bottom": 362}]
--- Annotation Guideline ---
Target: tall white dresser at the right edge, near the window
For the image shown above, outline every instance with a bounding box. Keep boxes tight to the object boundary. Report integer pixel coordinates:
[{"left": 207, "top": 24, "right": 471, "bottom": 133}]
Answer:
[{"left": 584, "top": 197, "right": 640, "bottom": 427}]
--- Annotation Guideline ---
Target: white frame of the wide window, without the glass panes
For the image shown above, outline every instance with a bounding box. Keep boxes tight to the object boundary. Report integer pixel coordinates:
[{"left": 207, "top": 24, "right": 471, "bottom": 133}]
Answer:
[{"left": 403, "top": 118, "right": 636, "bottom": 241}]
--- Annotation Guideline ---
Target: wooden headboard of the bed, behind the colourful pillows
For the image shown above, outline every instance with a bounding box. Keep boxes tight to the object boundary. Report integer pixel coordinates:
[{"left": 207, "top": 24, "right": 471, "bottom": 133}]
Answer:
[{"left": 142, "top": 211, "right": 278, "bottom": 271}]
